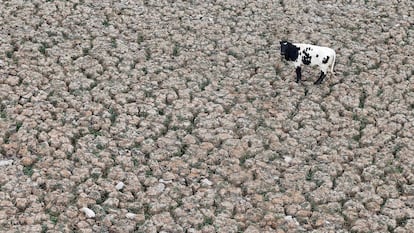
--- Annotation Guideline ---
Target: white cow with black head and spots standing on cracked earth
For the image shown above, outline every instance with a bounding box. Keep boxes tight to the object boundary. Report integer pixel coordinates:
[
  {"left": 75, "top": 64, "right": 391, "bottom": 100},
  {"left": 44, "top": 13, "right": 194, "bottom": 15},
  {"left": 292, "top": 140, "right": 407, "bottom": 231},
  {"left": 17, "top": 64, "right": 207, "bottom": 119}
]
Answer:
[{"left": 280, "top": 41, "right": 336, "bottom": 84}]
